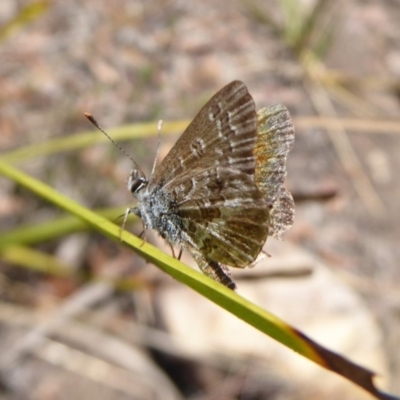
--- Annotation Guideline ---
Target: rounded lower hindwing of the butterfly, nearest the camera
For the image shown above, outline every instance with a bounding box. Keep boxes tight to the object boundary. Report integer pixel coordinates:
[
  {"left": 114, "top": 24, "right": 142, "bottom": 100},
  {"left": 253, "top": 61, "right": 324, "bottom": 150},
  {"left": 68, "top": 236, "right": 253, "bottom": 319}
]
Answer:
[{"left": 173, "top": 167, "right": 269, "bottom": 268}]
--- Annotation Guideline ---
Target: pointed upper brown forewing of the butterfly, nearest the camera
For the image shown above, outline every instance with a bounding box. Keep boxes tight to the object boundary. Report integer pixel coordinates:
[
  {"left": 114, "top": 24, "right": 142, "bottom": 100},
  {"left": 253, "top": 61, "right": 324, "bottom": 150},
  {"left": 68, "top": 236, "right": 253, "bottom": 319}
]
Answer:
[{"left": 149, "top": 81, "right": 257, "bottom": 186}]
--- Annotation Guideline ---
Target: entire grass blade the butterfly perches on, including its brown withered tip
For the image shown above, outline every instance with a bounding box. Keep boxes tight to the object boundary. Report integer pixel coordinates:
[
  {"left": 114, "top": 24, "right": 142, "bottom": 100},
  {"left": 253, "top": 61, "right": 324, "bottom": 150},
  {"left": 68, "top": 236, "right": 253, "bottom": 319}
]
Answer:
[{"left": 0, "top": 160, "right": 392, "bottom": 399}]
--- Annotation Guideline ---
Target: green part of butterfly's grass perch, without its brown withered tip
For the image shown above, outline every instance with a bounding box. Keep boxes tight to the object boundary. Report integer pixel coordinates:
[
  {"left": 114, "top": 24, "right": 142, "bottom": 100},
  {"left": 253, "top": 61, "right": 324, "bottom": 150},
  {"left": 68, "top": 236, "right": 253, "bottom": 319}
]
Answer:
[{"left": 0, "top": 161, "right": 318, "bottom": 360}]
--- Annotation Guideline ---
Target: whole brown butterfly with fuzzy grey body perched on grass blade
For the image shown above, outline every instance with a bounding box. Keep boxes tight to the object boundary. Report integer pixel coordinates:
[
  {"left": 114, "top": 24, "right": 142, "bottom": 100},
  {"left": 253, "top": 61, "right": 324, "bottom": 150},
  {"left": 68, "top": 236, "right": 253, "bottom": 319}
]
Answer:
[{"left": 88, "top": 81, "right": 294, "bottom": 289}]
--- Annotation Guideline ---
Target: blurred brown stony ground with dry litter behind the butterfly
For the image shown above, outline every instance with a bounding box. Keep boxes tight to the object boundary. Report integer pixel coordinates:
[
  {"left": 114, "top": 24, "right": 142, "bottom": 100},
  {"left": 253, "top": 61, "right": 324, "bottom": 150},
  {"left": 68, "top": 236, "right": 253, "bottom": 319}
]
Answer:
[{"left": 0, "top": 0, "right": 400, "bottom": 399}]
